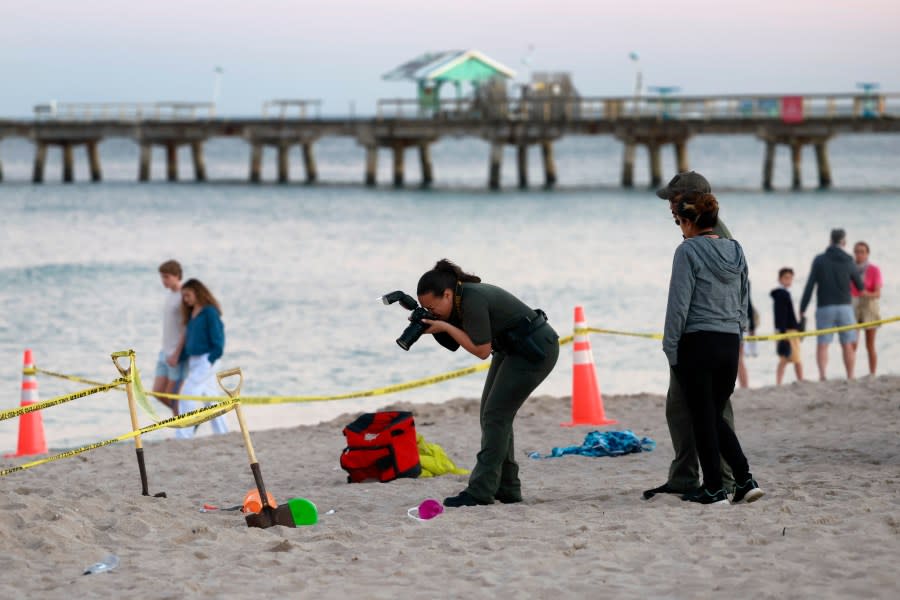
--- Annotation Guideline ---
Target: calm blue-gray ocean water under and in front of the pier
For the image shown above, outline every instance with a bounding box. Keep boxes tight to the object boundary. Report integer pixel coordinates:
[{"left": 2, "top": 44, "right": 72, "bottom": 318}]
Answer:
[{"left": 0, "top": 136, "right": 900, "bottom": 451}]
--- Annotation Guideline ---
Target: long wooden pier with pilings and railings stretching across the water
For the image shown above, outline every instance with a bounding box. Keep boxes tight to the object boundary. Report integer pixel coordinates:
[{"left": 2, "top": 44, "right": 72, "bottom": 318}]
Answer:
[{"left": 0, "top": 94, "right": 900, "bottom": 190}]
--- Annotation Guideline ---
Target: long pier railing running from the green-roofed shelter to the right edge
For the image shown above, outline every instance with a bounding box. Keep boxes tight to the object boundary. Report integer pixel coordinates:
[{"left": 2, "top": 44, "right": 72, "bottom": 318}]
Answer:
[{"left": 376, "top": 94, "right": 900, "bottom": 121}]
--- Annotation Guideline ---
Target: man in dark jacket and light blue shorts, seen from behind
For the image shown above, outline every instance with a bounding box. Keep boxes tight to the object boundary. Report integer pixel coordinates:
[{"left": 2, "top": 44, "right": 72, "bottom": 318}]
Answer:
[{"left": 800, "top": 229, "right": 865, "bottom": 381}]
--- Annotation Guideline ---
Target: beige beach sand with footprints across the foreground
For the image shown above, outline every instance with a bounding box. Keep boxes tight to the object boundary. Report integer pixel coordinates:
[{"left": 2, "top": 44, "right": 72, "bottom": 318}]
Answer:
[{"left": 0, "top": 377, "right": 900, "bottom": 598}]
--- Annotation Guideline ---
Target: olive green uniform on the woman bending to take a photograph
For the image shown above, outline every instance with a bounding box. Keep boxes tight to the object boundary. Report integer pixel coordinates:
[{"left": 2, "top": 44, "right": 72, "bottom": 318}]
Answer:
[{"left": 435, "top": 283, "right": 559, "bottom": 503}]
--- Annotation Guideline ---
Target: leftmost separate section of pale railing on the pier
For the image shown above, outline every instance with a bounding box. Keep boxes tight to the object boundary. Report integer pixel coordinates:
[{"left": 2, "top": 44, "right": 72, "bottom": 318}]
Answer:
[{"left": 34, "top": 102, "right": 216, "bottom": 121}]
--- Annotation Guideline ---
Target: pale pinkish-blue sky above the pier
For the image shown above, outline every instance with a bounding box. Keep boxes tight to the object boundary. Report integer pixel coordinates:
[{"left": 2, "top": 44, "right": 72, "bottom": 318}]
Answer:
[{"left": 0, "top": 0, "right": 900, "bottom": 118}]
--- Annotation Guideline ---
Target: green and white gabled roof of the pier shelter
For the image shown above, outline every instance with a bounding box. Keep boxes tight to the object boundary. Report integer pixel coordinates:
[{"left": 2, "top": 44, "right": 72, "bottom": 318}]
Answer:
[{"left": 382, "top": 50, "right": 516, "bottom": 81}]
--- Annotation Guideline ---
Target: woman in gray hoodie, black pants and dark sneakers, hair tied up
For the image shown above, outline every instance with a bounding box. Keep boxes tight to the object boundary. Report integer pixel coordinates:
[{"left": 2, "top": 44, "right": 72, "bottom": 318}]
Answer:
[{"left": 663, "top": 192, "right": 763, "bottom": 504}]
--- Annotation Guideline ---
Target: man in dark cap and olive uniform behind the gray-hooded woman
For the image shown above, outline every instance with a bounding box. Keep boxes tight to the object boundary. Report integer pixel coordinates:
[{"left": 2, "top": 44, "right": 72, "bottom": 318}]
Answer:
[{"left": 644, "top": 171, "right": 734, "bottom": 500}]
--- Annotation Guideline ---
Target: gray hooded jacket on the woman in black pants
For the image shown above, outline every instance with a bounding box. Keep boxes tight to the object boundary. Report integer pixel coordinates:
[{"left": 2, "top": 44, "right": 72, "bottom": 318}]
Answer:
[{"left": 663, "top": 236, "right": 749, "bottom": 366}]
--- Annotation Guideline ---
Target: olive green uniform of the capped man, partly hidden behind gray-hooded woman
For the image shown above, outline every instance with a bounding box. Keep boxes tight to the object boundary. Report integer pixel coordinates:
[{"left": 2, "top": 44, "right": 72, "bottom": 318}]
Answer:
[{"left": 666, "top": 220, "right": 734, "bottom": 493}]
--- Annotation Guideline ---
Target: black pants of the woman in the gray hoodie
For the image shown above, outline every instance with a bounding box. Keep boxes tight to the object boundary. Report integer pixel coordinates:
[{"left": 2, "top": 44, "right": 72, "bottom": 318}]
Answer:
[{"left": 674, "top": 331, "right": 750, "bottom": 492}]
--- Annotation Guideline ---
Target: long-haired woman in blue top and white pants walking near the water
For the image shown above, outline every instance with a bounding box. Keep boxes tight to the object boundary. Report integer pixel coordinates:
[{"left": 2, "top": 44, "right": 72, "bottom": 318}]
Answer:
[{"left": 175, "top": 279, "right": 228, "bottom": 439}]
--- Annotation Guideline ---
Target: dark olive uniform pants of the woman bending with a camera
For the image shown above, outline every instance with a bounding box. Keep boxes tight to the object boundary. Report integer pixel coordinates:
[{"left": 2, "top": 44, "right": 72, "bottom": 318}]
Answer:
[{"left": 466, "top": 325, "right": 559, "bottom": 502}]
